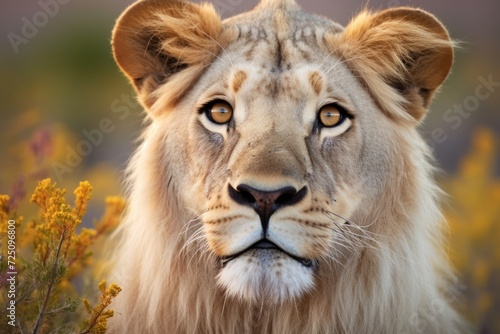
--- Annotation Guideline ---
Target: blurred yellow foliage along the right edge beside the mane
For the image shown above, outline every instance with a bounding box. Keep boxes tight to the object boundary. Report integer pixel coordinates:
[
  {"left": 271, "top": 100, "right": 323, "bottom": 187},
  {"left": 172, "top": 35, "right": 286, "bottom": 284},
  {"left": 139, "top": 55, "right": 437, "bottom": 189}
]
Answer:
[{"left": 444, "top": 130, "right": 500, "bottom": 333}]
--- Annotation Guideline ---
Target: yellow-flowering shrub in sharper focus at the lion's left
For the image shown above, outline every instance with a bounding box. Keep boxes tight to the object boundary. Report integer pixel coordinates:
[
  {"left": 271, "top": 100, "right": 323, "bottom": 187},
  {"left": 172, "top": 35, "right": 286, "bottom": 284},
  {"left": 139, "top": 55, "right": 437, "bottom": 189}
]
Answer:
[{"left": 0, "top": 179, "right": 124, "bottom": 334}]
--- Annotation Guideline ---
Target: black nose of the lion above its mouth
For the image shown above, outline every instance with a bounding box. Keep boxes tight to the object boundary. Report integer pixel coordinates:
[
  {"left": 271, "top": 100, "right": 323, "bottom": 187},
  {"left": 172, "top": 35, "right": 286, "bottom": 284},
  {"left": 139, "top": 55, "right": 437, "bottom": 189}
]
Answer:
[{"left": 229, "top": 184, "right": 307, "bottom": 231}]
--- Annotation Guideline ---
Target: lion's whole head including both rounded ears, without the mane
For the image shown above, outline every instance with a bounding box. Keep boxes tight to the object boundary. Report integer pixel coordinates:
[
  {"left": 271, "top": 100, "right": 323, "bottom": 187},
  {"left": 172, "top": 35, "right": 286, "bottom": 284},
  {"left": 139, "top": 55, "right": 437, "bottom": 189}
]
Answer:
[{"left": 114, "top": 1, "right": 452, "bottom": 303}]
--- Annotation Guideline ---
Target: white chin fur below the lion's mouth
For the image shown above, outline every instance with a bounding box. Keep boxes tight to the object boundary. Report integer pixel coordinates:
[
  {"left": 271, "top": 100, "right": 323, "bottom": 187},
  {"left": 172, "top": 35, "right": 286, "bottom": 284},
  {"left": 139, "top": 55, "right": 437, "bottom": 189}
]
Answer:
[{"left": 217, "top": 249, "right": 314, "bottom": 304}]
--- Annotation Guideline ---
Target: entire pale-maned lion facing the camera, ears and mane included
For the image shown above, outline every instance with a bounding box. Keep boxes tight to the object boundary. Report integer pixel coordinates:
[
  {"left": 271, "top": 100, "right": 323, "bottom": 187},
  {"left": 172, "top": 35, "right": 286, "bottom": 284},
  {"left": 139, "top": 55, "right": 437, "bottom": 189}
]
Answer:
[{"left": 111, "top": 0, "right": 465, "bottom": 334}]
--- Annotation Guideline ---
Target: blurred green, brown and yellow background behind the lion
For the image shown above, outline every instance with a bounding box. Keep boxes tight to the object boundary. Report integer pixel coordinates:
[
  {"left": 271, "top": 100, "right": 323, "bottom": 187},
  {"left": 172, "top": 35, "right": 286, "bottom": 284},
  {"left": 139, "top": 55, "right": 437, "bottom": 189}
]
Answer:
[{"left": 0, "top": 0, "right": 500, "bottom": 333}]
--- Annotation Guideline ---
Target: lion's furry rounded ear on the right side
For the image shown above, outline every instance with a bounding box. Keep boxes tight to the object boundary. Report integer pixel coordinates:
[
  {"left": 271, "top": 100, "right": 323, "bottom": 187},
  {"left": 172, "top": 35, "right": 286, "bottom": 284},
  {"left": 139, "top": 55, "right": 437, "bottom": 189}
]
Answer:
[{"left": 340, "top": 7, "right": 453, "bottom": 121}]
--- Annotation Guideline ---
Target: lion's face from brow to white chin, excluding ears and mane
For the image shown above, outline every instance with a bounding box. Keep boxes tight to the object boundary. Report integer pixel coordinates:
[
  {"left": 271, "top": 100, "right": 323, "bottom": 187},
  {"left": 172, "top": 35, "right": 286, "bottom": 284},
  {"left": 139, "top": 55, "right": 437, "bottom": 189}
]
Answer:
[{"left": 178, "top": 52, "right": 376, "bottom": 302}]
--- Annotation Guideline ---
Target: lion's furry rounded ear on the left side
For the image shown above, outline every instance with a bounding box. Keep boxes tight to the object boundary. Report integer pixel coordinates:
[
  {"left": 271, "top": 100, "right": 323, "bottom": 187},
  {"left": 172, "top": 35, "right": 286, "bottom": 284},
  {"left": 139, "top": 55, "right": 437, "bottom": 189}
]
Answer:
[{"left": 112, "top": 0, "right": 222, "bottom": 110}]
